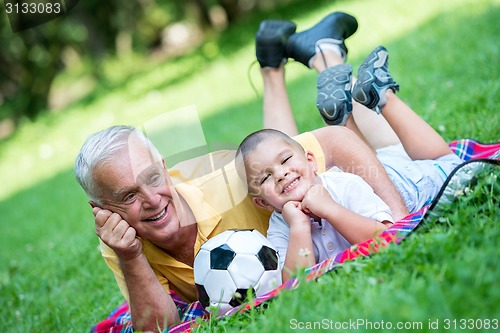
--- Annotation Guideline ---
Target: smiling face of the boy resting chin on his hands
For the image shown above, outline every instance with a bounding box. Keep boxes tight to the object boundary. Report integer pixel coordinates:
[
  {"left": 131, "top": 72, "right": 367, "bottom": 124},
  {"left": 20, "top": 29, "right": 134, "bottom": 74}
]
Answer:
[{"left": 246, "top": 138, "right": 317, "bottom": 212}]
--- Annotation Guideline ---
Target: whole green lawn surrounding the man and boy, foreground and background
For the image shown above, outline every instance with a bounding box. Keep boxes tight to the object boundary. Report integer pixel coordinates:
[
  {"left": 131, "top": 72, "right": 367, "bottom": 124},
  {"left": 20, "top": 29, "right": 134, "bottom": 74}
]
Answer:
[{"left": 0, "top": 0, "right": 500, "bottom": 332}]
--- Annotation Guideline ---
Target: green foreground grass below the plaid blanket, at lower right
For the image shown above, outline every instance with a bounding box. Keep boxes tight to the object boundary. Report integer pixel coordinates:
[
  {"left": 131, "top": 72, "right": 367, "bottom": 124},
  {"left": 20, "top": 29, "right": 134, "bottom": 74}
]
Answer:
[{"left": 197, "top": 167, "right": 500, "bottom": 332}]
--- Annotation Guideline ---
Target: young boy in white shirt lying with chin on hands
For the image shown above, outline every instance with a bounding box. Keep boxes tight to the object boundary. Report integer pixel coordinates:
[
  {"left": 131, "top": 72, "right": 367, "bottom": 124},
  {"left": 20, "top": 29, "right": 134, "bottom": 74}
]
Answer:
[{"left": 237, "top": 47, "right": 462, "bottom": 280}]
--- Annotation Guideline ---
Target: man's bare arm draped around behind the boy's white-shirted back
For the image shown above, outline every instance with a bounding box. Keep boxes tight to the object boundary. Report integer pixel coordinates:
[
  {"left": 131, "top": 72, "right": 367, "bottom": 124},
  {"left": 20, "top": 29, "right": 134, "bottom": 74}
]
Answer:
[{"left": 312, "top": 126, "right": 408, "bottom": 221}]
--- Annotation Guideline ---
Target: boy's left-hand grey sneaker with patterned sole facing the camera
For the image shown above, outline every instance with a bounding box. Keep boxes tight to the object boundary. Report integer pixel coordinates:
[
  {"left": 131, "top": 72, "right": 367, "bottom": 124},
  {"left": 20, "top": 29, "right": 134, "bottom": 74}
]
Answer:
[{"left": 316, "top": 64, "right": 352, "bottom": 125}]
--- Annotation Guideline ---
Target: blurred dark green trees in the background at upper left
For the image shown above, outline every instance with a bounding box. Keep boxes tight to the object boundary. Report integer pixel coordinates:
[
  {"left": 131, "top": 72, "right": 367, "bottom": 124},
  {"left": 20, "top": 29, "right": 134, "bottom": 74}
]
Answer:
[{"left": 0, "top": 0, "right": 292, "bottom": 135}]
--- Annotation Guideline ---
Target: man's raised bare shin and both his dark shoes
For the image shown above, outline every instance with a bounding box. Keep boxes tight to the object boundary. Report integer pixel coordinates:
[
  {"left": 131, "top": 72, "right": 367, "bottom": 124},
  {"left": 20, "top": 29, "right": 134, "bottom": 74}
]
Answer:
[{"left": 256, "top": 12, "right": 358, "bottom": 136}]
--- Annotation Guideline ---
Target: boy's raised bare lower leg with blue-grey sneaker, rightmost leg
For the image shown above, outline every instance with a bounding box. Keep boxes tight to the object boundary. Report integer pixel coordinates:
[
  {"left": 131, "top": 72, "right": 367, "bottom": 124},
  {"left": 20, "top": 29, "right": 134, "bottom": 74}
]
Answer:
[{"left": 353, "top": 46, "right": 452, "bottom": 160}]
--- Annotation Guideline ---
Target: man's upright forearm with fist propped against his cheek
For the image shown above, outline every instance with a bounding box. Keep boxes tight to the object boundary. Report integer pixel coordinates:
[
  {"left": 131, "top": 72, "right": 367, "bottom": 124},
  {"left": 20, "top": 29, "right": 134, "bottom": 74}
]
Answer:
[{"left": 92, "top": 207, "right": 179, "bottom": 332}]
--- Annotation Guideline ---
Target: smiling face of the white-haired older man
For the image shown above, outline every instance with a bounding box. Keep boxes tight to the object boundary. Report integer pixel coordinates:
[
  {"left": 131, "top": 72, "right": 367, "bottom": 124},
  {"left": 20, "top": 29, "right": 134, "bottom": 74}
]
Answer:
[{"left": 94, "top": 135, "right": 180, "bottom": 242}]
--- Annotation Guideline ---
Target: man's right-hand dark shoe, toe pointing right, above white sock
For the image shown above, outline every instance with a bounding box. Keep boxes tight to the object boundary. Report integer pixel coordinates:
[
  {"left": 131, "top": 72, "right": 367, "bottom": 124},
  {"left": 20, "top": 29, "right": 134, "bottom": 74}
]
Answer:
[{"left": 286, "top": 12, "right": 358, "bottom": 67}]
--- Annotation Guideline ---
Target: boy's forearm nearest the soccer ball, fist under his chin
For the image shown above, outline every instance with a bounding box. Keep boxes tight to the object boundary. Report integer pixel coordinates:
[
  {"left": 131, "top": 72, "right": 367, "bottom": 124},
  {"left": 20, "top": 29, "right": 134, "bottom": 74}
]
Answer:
[{"left": 281, "top": 201, "right": 316, "bottom": 282}]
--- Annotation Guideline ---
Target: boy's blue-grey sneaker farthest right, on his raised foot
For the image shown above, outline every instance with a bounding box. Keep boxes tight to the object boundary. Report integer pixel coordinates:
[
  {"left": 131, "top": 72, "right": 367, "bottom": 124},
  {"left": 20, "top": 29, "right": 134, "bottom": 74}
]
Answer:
[{"left": 352, "top": 46, "right": 399, "bottom": 113}]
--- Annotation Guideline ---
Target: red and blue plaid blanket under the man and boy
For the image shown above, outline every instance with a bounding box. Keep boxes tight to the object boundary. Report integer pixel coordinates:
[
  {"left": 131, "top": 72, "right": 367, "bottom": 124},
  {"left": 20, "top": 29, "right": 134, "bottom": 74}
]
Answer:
[{"left": 91, "top": 139, "right": 500, "bottom": 333}]
